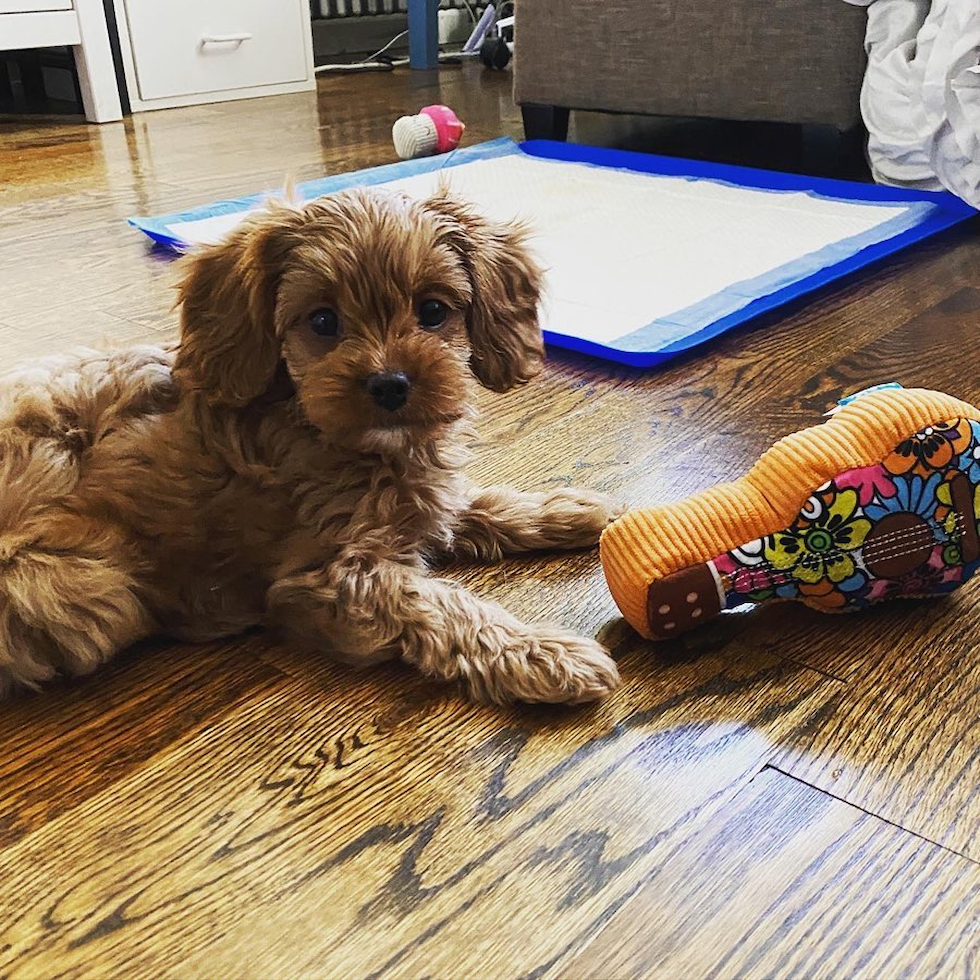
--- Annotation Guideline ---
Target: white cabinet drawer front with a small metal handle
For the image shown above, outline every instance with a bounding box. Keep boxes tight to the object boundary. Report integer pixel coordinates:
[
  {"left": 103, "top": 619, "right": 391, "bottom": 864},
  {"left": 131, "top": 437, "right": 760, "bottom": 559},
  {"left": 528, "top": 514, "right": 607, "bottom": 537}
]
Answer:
[{"left": 126, "top": 0, "right": 309, "bottom": 100}]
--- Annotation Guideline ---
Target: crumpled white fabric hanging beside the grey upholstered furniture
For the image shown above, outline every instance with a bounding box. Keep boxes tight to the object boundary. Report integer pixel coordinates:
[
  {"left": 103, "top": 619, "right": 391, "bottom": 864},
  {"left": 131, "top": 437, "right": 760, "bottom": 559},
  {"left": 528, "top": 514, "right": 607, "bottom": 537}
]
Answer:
[{"left": 848, "top": 0, "right": 980, "bottom": 208}]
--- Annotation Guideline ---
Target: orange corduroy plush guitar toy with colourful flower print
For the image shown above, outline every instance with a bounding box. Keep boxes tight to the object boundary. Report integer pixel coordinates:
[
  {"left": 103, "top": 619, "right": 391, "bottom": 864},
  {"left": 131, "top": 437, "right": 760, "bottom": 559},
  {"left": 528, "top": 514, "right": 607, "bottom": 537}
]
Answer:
[{"left": 600, "top": 385, "right": 980, "bottom": 639}]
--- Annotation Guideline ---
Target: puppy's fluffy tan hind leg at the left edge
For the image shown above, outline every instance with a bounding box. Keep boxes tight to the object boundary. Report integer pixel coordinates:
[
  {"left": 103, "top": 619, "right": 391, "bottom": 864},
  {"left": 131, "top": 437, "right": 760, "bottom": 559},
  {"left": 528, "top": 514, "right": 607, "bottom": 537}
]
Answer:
[{"left": 0, "top": 524, "right": 154, "bottom": 695}]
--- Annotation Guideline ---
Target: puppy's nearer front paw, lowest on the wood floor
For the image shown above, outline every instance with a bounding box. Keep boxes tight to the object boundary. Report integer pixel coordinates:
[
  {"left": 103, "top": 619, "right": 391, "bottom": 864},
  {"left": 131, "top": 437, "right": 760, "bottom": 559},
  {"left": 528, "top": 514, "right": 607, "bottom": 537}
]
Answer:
[{"left": 462, "top": 626, "right": 619, "bottom": 704}]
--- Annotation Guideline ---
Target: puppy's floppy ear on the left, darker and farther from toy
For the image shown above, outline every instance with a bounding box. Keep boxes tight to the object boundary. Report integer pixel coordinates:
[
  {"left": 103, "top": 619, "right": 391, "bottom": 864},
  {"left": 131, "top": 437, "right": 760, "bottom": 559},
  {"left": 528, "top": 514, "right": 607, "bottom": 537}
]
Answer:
[{"left": 174, "top": 205, "right": 303, "bottom": 405}]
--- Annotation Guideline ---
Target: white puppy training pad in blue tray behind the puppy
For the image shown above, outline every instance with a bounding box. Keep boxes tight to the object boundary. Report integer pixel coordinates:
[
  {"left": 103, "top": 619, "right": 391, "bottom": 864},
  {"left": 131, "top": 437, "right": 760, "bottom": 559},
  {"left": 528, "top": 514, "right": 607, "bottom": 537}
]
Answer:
[{"left": 131, "top": 139, "right": 976, "bottom": 367}]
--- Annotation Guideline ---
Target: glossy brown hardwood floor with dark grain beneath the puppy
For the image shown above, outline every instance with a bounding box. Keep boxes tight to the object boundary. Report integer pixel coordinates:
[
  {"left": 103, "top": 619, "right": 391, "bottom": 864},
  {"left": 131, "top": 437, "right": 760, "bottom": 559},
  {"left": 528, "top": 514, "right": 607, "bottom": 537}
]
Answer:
[{"left": 0, "top": 69, "right": 980, "bottom": 978}]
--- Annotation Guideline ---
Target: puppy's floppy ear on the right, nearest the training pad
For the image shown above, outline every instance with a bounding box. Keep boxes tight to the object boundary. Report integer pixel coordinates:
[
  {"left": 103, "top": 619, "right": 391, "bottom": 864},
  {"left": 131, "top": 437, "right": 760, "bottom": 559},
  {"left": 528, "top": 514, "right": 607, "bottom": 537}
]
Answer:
[{"left": 425, "top": 189, "right": 544, "bottom": 391}]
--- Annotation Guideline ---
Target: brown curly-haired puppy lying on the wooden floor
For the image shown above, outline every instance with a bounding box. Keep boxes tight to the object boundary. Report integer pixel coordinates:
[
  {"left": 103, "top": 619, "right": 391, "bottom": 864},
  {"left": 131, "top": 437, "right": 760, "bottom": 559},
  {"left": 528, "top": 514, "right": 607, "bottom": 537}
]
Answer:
[{"left": 0, "top": 190, "right": 618, "bottom": 701}]
